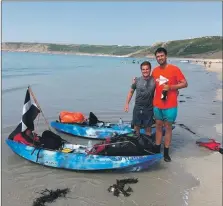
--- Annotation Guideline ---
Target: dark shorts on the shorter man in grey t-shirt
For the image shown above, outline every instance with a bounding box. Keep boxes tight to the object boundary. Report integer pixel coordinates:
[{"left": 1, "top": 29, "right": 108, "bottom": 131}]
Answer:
[{"left": 132, "top": 106, "right": 154, "bottom": 127}]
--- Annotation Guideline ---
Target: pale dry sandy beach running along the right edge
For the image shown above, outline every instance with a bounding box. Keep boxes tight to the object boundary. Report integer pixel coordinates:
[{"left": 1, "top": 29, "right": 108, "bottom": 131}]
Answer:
[{"left": 184, "top": 59, "right": 223, "bottom": 206}]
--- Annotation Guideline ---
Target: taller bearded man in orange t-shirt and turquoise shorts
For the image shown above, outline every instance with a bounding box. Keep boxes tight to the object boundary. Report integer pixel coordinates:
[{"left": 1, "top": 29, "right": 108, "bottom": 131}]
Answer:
[{"left": 152, "top": 48, "right": 188, "bottom": 162}]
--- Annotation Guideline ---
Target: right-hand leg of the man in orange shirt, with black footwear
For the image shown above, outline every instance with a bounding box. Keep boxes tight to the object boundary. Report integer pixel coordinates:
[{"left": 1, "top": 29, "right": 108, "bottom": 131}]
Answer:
[{"left": 164, "top": 122, "right": 172, "bottom": 162}]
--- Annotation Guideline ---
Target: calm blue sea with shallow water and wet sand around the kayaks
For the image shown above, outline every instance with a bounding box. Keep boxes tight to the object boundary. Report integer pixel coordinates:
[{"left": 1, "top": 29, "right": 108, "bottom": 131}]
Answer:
[{"left": 1, "top": 52, "right": 222, "bottom": 206}]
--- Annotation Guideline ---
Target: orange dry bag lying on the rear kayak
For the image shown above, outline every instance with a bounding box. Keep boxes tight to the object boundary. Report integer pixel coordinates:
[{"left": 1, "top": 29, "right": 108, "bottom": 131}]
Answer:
[{"left": 59, "top": 111, "right": 85, "bottom": 123}]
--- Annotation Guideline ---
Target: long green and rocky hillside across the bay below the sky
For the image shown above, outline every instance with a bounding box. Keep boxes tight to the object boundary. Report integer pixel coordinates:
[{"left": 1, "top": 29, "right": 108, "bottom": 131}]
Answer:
[{"left": 2, "top": 36, "right": 223, "bottom": 58}]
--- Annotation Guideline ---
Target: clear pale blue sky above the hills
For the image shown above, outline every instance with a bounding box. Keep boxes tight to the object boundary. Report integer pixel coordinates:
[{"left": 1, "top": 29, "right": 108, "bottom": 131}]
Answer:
[{"left": 2, "top": 1, "right": 222, "bottom": 45}]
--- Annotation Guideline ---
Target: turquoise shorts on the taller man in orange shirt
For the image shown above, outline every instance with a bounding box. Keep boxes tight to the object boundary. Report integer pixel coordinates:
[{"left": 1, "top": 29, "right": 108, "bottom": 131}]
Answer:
[{"left": 153, "top": 107, "right": 177, "bottom": 123}]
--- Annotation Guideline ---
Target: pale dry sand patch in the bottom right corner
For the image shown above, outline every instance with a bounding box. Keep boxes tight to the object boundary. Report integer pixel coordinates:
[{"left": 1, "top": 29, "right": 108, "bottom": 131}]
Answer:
[{"left": 185, "top": 152, "right": 222, "bottom": 206}]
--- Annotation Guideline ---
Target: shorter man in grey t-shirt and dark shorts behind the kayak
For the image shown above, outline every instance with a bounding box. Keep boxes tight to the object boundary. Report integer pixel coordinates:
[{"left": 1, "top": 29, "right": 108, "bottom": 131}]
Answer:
[{"left": 124, "top": 61, "right": 155, "bottom": 136}]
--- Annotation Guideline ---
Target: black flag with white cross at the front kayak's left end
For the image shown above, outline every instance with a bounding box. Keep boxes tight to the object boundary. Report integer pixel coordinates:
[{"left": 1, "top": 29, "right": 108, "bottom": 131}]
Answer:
[{"left": 9, "top": 89, "right": 40, "bottom": 139}]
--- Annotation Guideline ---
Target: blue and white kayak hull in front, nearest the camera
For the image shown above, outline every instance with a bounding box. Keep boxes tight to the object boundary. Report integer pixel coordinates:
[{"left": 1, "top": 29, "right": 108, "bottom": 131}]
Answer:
[{"left": 6, "top": 139, "right": 163, "bottom": 172}]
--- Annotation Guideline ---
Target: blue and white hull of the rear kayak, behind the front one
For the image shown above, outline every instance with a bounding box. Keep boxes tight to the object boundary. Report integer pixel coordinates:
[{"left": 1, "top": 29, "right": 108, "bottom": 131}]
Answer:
[{"left": 51, "top": 121, "right": 174, "bottom": 139}]
